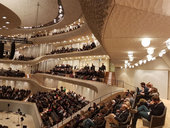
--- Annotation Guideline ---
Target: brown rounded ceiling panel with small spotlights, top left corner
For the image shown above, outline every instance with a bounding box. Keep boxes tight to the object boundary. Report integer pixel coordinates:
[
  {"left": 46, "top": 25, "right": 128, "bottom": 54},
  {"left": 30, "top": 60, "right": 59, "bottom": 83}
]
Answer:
[{"left": 0, "top": 4, "right": 21, "bottom": 32}]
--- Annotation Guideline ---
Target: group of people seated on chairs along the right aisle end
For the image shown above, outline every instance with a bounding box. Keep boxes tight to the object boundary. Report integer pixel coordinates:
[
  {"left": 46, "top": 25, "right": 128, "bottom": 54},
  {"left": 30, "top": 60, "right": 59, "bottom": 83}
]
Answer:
[{"left": 131, "top": 82, "right": 165, "bottom": 128}]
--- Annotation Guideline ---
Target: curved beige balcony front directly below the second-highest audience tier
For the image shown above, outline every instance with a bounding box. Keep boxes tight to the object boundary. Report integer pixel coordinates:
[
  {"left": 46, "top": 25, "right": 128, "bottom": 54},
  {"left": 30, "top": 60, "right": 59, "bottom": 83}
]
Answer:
[{"left": 0, "top": 45, "right": 106, "bottom": 65}]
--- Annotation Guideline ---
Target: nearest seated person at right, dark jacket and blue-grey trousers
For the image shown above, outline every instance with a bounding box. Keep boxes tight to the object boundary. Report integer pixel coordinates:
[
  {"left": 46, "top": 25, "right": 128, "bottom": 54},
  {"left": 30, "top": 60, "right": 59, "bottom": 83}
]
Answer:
[{"left": 131, "top": 95, "right": 165, "bottom": 128}]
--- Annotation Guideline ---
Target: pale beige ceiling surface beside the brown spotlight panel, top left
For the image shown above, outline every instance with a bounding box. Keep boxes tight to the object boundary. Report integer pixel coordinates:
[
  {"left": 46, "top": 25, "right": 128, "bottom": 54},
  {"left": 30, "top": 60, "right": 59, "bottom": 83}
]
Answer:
[{"left": 0, "top": 0, "right": 58, "bottom": 26}]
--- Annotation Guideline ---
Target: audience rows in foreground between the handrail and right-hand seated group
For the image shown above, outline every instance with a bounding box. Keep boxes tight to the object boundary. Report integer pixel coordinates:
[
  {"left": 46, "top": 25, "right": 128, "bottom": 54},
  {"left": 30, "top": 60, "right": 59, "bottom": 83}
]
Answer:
[{"left": 64, "top": 91, "right": 135, "bottom": 128}]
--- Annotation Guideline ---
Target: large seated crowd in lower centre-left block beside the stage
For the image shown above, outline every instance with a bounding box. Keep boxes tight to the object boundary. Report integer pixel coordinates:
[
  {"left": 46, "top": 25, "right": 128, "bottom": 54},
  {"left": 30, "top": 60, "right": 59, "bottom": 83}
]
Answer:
[{"left": 28, "top": 87, "right": 89, "bottom": 127}]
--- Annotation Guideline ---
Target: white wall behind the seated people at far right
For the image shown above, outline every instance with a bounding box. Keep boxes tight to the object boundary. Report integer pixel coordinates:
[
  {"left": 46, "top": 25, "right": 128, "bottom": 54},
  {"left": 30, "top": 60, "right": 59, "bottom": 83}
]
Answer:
[{"left": 115, "top": 58, "right": 170, "bottom": 99}]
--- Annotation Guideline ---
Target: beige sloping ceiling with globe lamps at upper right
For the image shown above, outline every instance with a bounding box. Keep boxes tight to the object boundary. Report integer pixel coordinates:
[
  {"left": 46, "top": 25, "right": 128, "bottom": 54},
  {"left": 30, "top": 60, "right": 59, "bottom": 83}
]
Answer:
[{"left": 102, "top": 0, "right": 170, "bottom": 66}]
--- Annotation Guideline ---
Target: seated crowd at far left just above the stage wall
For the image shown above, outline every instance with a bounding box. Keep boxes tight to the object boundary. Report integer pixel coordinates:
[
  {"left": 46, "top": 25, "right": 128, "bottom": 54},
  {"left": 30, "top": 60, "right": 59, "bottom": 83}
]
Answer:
[{"left": 0, "top": 85, "right": 31, "bottom": 101}]
